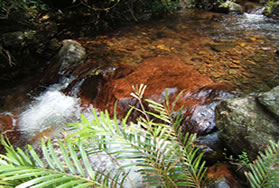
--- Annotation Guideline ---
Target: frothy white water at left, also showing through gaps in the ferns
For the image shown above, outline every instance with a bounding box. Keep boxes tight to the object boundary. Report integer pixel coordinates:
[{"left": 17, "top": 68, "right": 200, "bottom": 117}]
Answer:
[{"left": 19, "top": 79, "right": 147, "bottom": 188}]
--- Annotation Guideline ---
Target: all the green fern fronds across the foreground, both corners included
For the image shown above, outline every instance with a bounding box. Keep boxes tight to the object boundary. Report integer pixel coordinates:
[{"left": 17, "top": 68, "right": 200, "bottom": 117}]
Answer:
[{"left": 0, "top": 85, "right": 279, "bottom": 188}]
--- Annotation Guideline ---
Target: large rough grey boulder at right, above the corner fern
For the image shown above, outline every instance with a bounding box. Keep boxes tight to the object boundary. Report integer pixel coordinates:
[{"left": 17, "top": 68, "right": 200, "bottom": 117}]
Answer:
[{"left": 216, "top": 86, "right": 279, "bottom": 160}]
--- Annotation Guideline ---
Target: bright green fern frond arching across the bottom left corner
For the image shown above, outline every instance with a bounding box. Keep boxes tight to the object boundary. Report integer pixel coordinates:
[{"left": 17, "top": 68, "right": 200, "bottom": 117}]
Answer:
[{"left": 0, "top": 138, "right": 125, "bottom": 188}]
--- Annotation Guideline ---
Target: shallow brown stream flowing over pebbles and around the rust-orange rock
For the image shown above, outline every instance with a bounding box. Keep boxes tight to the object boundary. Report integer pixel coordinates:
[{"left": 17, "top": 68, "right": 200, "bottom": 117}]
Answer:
[{"left": 0, "top": 7, "right": 279, "bottom": 187}]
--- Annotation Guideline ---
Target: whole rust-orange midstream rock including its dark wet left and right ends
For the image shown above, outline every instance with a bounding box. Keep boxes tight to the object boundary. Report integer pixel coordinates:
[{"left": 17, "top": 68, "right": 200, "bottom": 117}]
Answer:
[{"left": 80, "top": 57, "right": 236, "bottom": 133}]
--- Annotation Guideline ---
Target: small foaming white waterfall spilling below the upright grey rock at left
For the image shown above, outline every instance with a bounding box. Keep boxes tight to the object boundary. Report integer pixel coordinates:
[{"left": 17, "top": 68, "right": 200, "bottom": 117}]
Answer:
[{"left": 19, "top": 78, "right": 81, "bottom": 141}]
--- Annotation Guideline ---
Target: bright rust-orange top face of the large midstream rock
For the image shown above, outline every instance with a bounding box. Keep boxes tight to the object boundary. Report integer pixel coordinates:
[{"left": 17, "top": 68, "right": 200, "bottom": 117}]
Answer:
[{"left": 94, "top": 57, "right": 213, "bottom": 115}]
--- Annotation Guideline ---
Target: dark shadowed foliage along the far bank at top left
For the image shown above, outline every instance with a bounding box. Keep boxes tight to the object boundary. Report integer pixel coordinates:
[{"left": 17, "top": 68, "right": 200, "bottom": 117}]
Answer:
[{"left": 0, "top": 0, "right": 179, "bottom": 30}]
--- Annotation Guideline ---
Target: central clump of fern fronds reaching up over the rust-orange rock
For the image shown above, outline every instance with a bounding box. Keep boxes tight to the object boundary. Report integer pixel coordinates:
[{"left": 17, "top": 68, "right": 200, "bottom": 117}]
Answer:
[{"left": 68, "top": 86, "right": 206, "bottom": 187}]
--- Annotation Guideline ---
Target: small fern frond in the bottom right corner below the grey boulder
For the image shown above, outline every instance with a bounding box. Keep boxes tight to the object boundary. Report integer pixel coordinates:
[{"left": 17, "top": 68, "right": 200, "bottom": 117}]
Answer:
[{"left": 245, "top": 141, "right": 279, "bottom": 188}]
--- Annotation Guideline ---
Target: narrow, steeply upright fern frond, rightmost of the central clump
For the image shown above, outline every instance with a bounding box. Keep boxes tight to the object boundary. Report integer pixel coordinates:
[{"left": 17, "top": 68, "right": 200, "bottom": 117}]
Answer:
[{"left": 146, "top": 92, "right": 207, "bottom": 187}]
